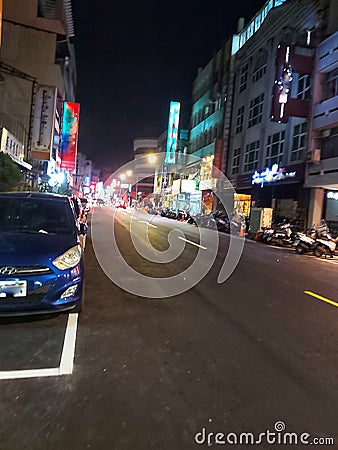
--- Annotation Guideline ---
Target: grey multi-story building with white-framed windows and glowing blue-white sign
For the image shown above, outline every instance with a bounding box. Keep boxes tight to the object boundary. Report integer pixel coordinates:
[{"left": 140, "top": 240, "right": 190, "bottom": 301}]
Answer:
[{"left": 223, "top": 0, "right": 334, "bottom": 224}]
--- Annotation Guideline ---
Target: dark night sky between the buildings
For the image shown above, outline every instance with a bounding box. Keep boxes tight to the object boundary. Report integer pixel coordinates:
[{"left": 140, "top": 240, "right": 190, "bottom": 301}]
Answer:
[{"left": 73, "top": 0, "right": 265, "bottom": 170}]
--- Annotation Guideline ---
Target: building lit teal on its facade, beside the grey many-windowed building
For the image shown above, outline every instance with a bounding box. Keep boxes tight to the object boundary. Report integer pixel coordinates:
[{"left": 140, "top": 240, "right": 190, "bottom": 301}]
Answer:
[{"left": 188, "top": 40, "right": 231, "bottom": 212}]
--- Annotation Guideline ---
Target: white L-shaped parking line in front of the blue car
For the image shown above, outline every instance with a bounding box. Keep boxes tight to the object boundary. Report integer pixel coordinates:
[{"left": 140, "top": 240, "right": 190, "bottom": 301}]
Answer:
[{"left": 0, "top": 313, "right": 78, "bottom": 380}]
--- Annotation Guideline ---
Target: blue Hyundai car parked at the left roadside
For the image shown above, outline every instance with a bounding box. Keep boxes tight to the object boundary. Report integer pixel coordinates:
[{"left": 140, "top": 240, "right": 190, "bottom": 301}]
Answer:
[{"left": 0, "top": 192, "right": 84, "bottom": 316}]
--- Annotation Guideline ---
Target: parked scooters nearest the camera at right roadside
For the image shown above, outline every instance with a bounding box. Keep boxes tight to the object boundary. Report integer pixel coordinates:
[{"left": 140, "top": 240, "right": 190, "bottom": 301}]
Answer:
[{"left": 255, "top": 220, "right": 338, "bottom": 258}]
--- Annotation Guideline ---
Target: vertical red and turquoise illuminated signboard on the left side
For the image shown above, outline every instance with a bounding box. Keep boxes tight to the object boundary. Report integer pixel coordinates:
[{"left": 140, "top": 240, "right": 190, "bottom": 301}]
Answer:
[{"left": 61, "top": 102, "right": 80, "bottom": 172}]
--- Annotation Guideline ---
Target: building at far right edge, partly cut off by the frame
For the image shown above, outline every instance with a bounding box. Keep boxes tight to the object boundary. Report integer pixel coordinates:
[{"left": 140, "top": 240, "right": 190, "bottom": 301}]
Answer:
[{"left": 306, "top": 26, "right": 338, "bottom": 228}]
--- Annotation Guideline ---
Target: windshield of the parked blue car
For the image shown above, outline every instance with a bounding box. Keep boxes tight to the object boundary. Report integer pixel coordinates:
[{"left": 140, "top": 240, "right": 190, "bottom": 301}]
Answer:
[{"left": 0, "top": 197, "right": 74, "bottom": 234}]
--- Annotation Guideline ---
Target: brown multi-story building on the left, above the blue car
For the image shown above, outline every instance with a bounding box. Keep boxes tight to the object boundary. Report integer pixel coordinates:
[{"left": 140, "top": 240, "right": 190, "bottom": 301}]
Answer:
[{"left": 0, "top": 0, "right": 76, "bottom": 183}]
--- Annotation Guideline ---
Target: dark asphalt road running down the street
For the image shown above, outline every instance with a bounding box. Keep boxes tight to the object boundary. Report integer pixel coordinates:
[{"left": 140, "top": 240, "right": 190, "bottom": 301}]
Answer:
[{"left": 0, "top": 208, "right": 338, "bottom": 450}]
